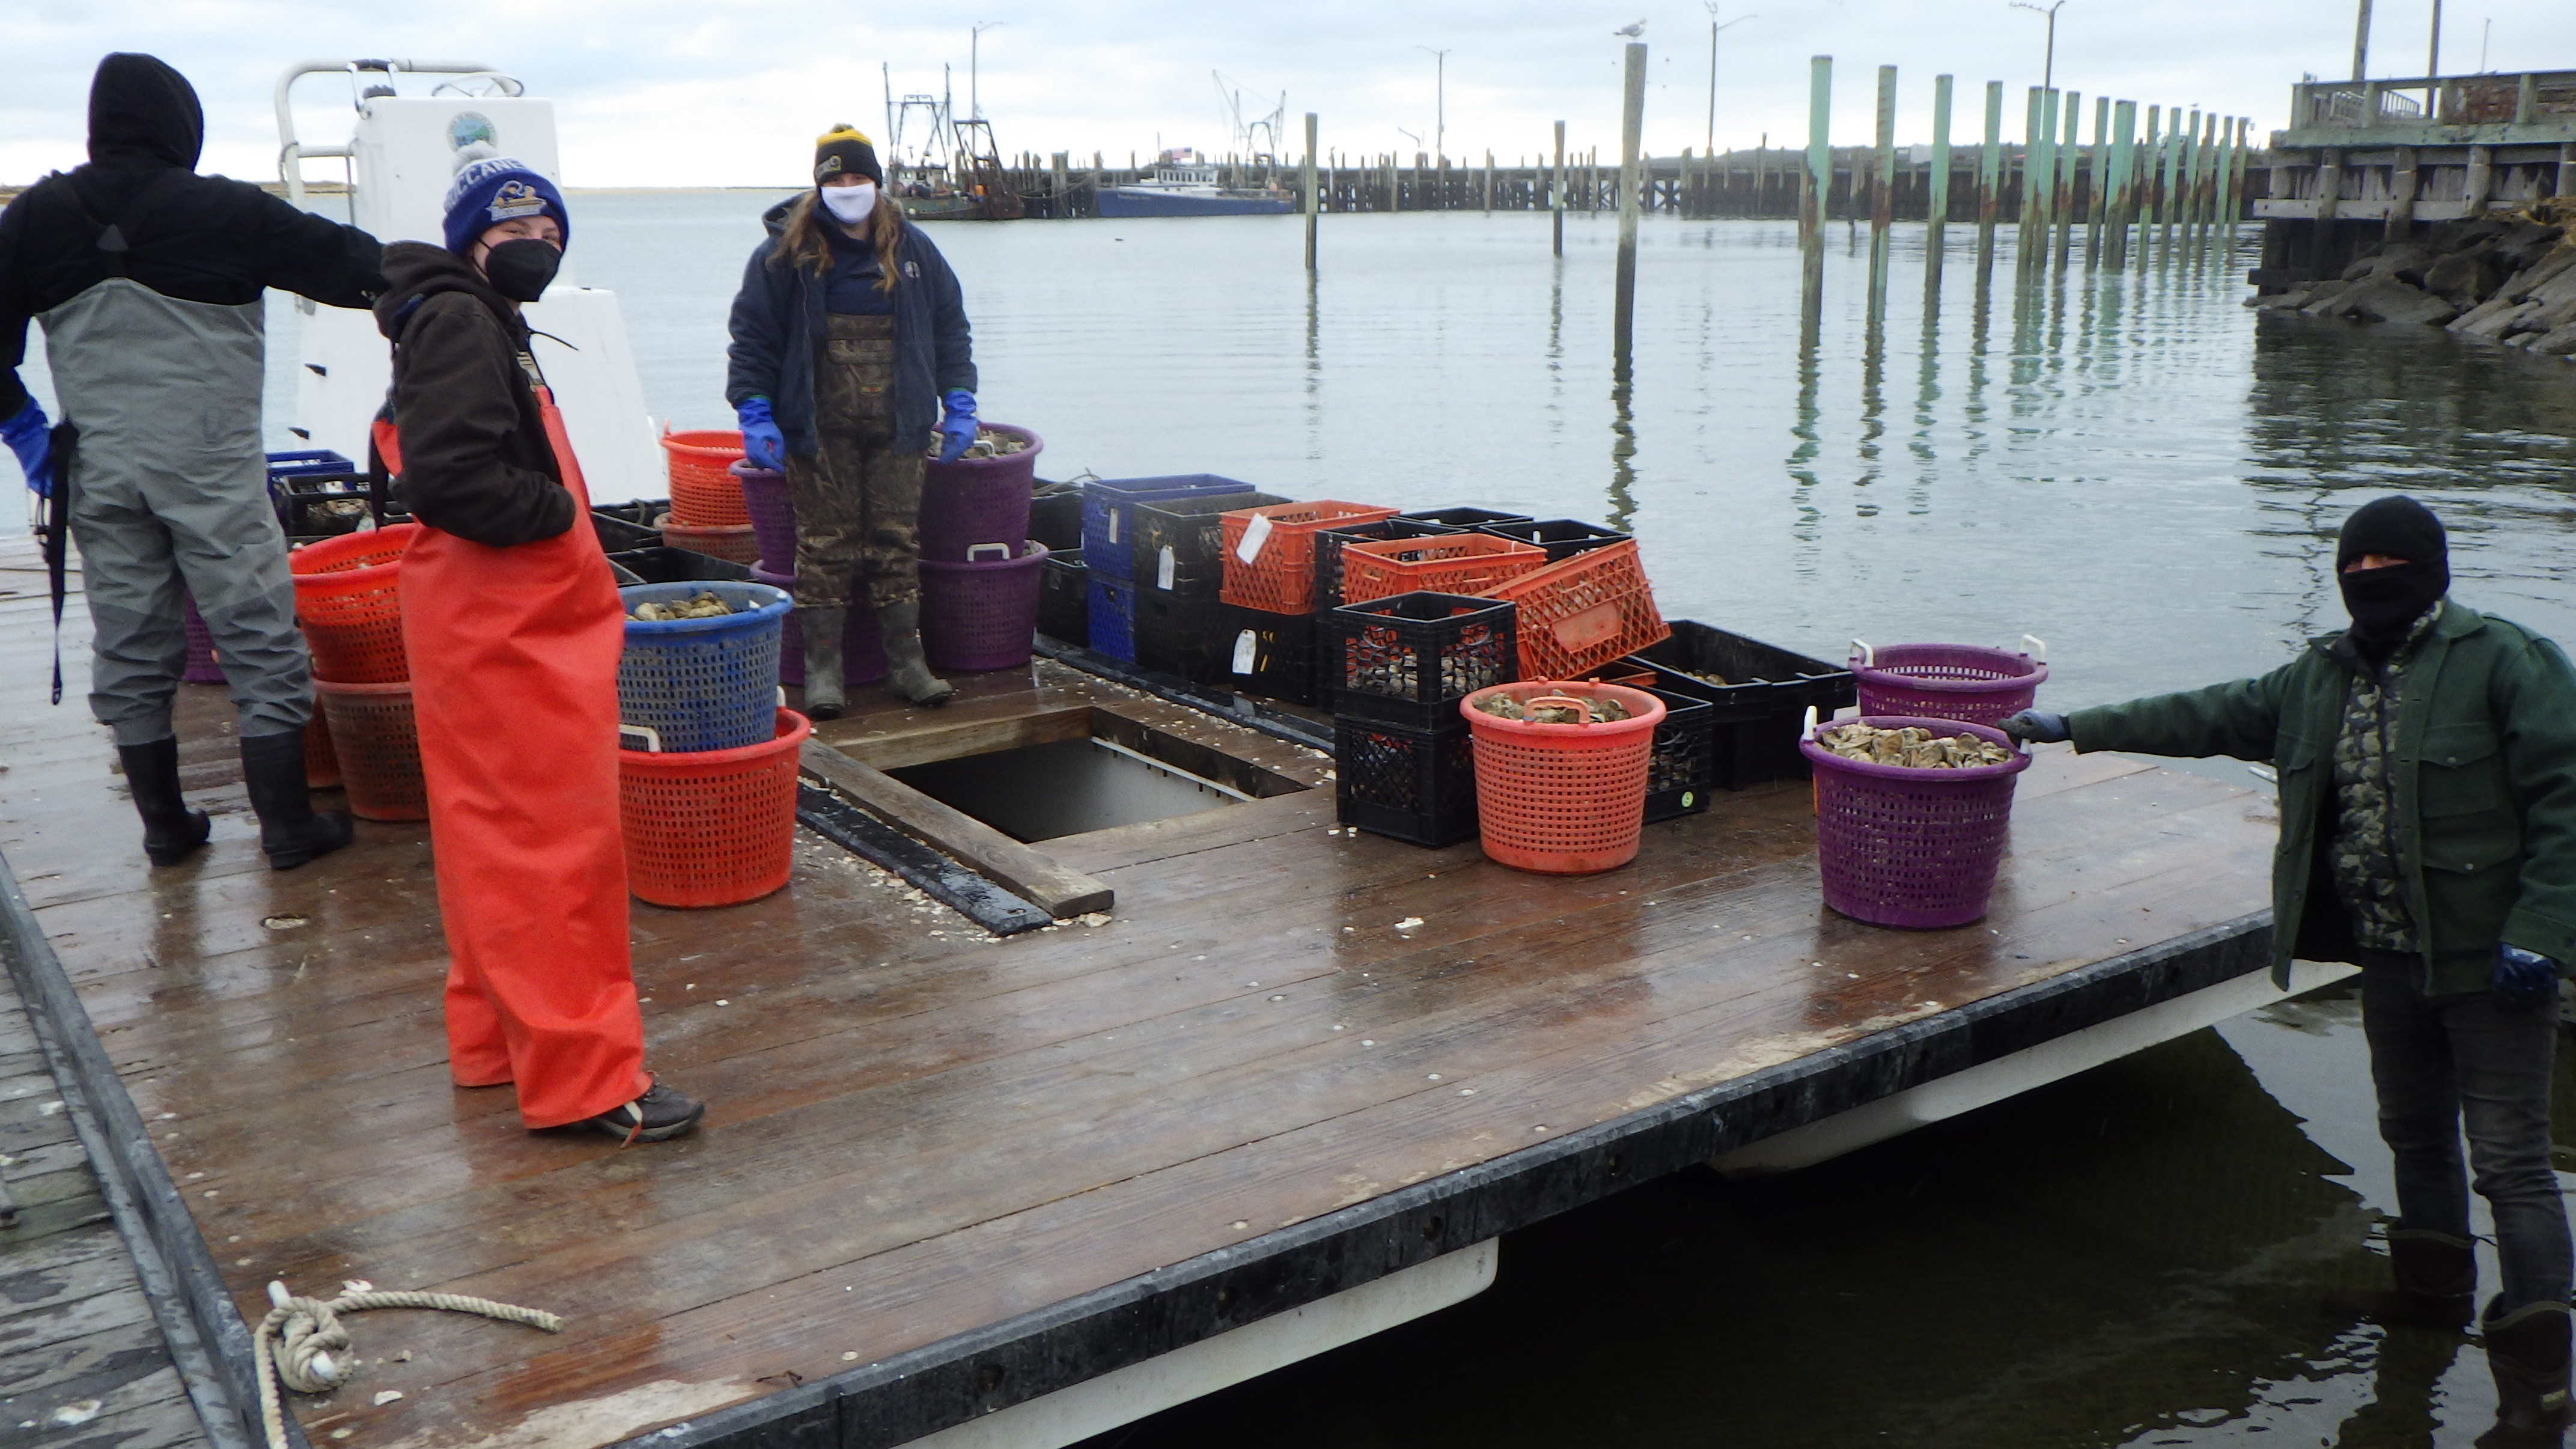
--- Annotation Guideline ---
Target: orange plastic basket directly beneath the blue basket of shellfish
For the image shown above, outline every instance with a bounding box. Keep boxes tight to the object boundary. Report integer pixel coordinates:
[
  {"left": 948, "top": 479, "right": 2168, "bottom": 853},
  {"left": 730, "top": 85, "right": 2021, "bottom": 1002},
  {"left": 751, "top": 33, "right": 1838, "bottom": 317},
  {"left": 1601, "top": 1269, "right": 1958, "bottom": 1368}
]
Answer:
[{"left": 618, "top": 709, "right": 814, "bottom": 905}]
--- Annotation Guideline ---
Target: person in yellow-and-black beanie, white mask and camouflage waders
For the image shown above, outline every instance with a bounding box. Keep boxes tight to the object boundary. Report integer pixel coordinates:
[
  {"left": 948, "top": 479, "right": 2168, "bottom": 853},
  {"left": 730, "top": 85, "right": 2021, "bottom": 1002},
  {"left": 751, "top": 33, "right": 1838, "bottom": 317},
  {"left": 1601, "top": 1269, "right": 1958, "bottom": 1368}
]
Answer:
[{"left": 724, "top": 126, "right": 976, "bottom": 719}]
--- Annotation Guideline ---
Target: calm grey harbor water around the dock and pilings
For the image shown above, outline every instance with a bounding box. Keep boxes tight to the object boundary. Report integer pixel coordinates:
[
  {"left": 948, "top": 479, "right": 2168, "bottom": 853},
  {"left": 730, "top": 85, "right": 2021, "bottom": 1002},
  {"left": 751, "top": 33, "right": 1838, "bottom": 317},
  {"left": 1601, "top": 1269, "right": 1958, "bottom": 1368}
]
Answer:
[{"left": 15, "top": 191, "right": 2576, "bottom": 1449}]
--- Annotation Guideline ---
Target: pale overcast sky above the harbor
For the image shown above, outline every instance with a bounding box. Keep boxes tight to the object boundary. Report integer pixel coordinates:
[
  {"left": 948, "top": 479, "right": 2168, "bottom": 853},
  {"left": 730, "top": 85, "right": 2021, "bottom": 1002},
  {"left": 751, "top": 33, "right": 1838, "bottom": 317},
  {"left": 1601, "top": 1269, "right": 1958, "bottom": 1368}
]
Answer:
[{"left": 0, "top": 0, "right": 2576, "bottom": 186}]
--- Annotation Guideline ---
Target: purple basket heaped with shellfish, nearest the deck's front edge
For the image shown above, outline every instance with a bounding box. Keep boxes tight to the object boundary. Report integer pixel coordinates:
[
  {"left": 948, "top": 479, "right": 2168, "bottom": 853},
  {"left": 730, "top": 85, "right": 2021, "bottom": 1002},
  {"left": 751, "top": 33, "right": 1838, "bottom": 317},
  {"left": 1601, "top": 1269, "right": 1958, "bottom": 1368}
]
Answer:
[{"left": 1798, "top": 714, "right": 2030, "bottom": 931}]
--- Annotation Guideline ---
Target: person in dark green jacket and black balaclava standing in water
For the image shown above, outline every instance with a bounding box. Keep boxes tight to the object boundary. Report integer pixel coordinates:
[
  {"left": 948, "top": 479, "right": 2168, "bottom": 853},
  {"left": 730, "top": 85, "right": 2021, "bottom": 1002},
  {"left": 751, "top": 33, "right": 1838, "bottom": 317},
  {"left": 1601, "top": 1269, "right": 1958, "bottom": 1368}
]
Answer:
[{"left": 2004, "top": 498, "right": 2576, "bottom": 1449}]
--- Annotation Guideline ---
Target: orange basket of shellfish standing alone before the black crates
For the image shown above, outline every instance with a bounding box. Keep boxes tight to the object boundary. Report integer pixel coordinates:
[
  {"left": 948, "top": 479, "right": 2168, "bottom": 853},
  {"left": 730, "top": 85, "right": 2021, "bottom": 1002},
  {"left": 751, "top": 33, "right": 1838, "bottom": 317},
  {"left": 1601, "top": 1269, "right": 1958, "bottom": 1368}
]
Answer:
[{"left": 1458, "top": 683, "right": 1664, "bottom": 877}]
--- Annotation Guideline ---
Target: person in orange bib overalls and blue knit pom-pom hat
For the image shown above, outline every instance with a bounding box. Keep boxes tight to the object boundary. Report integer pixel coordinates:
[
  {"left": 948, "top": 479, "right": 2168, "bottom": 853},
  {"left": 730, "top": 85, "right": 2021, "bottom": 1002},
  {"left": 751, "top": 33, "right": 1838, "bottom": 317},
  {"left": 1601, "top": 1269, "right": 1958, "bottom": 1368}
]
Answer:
[{"left": 376, "top": 154, "right": 706, "bottom": 1142}]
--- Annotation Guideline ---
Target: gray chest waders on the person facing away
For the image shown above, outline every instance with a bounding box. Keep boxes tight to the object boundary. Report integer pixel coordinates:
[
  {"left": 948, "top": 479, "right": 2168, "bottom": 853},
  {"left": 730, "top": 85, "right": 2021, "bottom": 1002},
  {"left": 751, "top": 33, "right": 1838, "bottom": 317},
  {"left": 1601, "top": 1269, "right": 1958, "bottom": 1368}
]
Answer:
[{"left": 38, "top": 276, "right": 312, "bottom": 745}]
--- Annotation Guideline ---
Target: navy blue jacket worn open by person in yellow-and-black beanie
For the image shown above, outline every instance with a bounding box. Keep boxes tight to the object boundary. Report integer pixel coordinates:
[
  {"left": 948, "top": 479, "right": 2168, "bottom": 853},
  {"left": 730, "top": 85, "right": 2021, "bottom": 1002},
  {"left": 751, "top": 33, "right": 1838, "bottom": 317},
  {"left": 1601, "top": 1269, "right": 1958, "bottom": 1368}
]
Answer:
[{"left": 724, "top": 196, "right": 973, "bottom": 456}]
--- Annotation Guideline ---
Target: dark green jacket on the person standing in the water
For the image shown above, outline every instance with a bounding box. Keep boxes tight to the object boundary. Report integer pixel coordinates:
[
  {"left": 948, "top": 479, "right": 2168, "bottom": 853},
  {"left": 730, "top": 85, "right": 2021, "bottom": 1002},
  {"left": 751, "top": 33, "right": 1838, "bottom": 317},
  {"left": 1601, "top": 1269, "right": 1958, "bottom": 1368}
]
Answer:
[{"left": 2068, "top": 601, "right": 2576, "bottom": 995}]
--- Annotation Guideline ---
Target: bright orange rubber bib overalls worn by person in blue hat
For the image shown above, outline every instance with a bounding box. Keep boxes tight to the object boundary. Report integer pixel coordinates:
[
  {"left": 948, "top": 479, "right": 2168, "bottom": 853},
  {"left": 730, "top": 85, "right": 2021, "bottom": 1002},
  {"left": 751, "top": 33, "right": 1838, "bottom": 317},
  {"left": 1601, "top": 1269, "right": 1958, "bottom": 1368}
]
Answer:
[{"left": 379, "top": 387, "right": 652, "bottom": 1127}]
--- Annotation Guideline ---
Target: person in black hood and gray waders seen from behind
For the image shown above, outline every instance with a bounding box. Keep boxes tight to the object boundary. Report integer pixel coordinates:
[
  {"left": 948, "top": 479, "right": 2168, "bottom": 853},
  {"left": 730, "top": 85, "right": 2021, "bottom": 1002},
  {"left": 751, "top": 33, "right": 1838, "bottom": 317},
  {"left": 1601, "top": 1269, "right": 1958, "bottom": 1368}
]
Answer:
[{"left": 0, "top": 54, "right": 384, "bottom": 869}]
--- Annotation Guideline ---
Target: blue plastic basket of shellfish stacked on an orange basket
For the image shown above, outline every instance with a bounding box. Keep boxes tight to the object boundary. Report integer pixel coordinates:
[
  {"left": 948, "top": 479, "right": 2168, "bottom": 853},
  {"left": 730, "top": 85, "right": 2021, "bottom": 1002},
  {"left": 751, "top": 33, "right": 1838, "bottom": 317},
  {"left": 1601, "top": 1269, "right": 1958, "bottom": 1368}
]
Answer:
[{"left": 618, "top": 580, "right": 793, "bottom": 753}]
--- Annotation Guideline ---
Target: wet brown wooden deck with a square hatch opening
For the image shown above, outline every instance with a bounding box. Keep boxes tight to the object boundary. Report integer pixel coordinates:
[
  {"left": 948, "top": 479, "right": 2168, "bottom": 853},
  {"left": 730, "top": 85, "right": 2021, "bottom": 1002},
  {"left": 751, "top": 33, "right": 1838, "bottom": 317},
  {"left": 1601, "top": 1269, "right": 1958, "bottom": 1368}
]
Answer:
[{"left": 0, "top": 544, "right": 2274, "bottom": 1449}]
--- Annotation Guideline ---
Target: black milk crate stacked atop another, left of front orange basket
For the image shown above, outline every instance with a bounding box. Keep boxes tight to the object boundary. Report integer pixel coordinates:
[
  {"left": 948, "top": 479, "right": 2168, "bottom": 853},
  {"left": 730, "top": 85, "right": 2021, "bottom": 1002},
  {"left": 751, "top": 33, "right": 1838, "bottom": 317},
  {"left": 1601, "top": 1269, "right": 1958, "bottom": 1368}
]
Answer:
[{"left": 1321, "top": 593, "right": 1520, "bottom": 730}]
